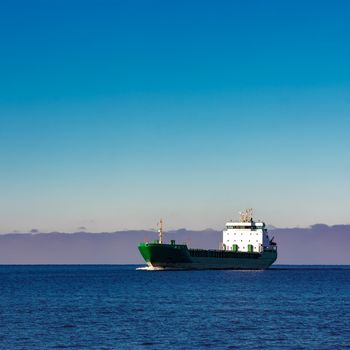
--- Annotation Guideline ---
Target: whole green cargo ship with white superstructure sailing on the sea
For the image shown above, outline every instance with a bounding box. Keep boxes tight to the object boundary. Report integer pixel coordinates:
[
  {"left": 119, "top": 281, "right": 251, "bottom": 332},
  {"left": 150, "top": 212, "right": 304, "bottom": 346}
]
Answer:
[{"left": 138, "top": 209, "right": 277, "bottom": 270}]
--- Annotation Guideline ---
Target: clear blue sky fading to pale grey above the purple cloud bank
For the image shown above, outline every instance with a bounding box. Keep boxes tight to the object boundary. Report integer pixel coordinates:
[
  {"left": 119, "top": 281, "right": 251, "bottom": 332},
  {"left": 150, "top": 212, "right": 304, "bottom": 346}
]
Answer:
[{"left": 0, "top": 0, "right": 350, "bottom": 232}]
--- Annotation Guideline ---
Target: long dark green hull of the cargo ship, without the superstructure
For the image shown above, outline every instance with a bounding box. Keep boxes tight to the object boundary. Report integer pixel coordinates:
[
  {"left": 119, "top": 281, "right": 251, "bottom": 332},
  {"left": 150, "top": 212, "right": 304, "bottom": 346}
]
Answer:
[{"left": 138, "top": 243, "right": 277, "bottom": 270}]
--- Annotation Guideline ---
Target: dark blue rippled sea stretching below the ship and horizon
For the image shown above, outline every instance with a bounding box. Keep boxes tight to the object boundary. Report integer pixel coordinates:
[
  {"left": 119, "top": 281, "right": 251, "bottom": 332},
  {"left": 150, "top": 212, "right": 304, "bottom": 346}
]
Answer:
[{"left": 0, "top": 265, "right": 350, "bottom": 350}]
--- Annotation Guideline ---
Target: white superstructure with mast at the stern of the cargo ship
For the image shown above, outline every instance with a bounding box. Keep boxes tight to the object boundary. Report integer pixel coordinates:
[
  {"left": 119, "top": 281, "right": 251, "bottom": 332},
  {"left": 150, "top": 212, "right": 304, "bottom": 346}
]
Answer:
[{"left": 222, "top": 209, "right": 276, "bottom": 253}]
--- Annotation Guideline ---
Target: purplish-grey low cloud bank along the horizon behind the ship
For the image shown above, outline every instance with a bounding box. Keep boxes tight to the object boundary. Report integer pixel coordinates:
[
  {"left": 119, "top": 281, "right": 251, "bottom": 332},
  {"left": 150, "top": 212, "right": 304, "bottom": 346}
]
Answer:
[{"left": 0, "top": 224, "right": 350, "bottom": 265}]
